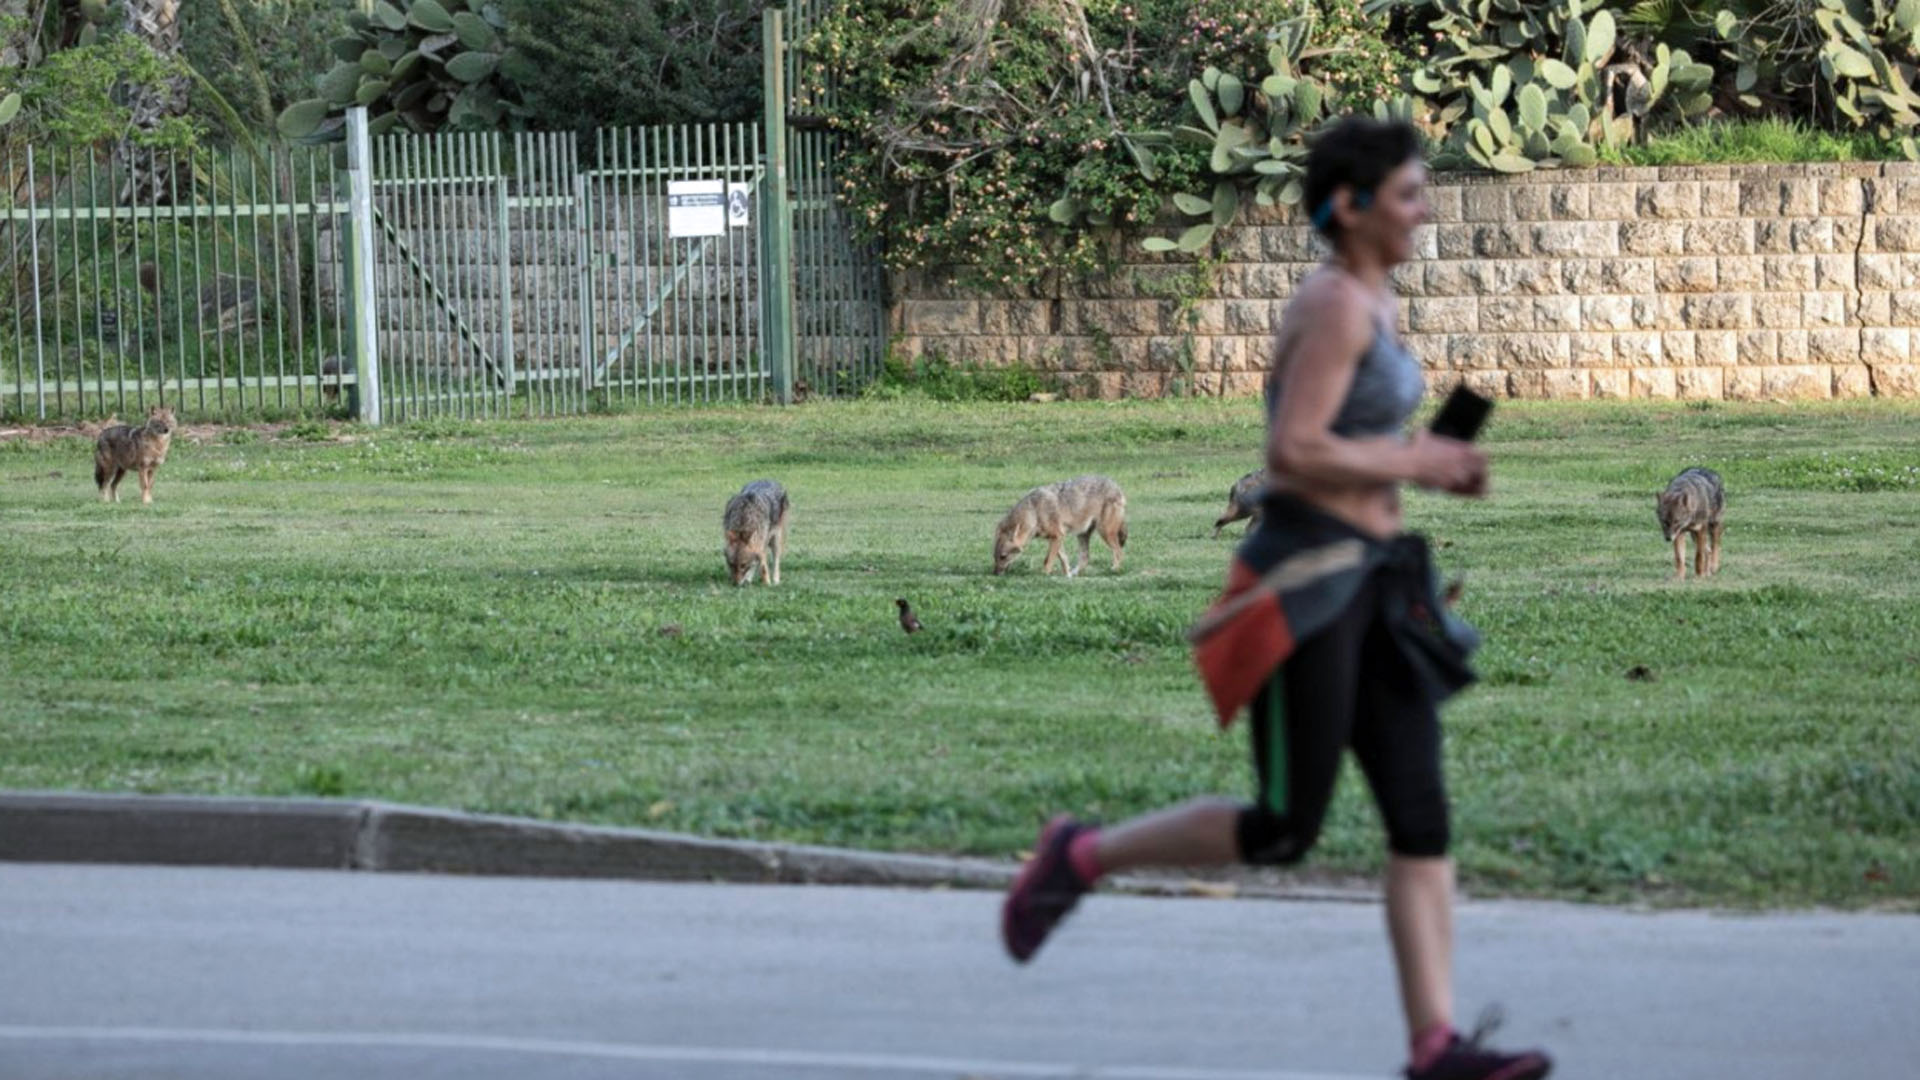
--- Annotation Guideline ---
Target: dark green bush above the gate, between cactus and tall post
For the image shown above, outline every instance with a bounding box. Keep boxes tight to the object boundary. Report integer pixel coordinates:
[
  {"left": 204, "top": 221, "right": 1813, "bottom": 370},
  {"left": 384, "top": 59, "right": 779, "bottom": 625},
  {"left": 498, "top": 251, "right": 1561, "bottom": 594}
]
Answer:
[{"left": 507, "top": 0, "right": 762, "bottom": 131}]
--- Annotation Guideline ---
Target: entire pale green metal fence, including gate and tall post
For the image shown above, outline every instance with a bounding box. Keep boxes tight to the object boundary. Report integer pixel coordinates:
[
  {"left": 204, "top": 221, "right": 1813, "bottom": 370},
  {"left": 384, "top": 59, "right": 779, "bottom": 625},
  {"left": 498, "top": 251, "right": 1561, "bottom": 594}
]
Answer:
[{"left": 0, "top": 0, "right": 885, "bottom": 423}]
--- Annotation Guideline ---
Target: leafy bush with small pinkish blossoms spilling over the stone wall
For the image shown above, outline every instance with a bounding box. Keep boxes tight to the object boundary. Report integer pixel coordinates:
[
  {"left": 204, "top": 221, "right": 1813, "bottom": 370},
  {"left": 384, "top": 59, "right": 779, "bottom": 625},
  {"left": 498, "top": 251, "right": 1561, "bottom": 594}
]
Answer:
[{"left": 803, "top": 0, "right": 1402, "bottom": 286}]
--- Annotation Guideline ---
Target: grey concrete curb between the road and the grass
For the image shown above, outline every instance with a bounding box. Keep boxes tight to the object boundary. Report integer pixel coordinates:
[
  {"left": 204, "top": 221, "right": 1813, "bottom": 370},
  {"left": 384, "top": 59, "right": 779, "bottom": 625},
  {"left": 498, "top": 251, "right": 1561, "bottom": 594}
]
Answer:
[{"left": 0, "top": 780, "right": 1377, "bottom": 901}]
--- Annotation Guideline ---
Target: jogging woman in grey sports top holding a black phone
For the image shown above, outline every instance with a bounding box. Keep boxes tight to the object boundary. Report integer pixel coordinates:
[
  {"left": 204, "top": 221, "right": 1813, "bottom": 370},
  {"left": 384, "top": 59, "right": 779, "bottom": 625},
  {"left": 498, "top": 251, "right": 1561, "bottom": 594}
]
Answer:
[{"left": 1000, "top": 117, "right": 1551, "bottom": 1080}]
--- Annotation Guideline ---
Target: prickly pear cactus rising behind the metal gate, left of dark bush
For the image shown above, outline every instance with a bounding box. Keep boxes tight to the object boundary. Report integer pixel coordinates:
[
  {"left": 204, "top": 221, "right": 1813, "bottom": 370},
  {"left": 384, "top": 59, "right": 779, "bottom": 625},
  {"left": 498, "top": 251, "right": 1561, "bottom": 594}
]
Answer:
[{"left": 278, "top": 0, "right": 538, "bottom": 142}]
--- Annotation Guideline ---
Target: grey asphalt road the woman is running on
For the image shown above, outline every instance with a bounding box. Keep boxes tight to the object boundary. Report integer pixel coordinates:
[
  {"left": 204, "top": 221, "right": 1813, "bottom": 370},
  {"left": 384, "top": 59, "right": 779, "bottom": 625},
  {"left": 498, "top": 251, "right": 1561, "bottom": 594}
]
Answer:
[{"left": 0, "top": 863, "right": 1920, "bottom": 1080}]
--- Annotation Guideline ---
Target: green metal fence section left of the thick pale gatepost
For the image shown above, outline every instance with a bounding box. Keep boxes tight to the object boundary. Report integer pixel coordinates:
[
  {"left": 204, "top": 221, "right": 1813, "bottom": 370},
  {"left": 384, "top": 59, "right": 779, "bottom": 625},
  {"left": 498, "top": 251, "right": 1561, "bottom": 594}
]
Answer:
[{"left": 0, "top": 146, "right": 353, "bottom": 421}]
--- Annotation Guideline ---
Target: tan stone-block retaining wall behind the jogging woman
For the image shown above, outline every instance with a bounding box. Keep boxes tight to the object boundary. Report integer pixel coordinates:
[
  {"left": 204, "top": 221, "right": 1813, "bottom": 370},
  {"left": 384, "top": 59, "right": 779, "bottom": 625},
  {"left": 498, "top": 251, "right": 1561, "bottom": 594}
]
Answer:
[{"left": 891, "top": 163, "right": 1920, "bottom": 400}]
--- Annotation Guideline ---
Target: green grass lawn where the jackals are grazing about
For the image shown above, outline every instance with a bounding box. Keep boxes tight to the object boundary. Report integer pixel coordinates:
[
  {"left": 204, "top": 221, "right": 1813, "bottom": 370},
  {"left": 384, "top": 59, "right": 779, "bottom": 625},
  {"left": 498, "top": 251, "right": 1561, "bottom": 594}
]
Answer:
[{"left": 0, "top": 402, "right": 1920, "bottom": 907}]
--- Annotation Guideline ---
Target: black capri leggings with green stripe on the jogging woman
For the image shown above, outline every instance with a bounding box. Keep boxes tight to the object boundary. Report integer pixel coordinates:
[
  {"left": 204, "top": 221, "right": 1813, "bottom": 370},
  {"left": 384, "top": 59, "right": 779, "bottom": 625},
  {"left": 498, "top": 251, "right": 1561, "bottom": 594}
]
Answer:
[{"left": 1238, "top": 577, "right": 1448, "bottom": 865}]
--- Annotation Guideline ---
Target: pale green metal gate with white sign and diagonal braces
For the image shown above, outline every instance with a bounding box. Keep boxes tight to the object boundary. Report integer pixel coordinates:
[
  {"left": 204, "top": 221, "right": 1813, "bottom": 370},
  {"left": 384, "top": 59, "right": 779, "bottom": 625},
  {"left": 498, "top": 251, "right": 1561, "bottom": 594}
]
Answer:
[{"left": 357, "top": 125, "right": 770, "bottom": 421}]
